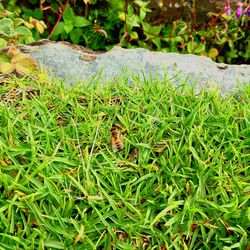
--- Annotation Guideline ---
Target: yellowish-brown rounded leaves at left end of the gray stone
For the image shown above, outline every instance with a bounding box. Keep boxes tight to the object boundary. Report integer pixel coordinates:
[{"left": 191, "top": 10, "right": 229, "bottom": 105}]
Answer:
[{"left": 0, "top": 47, "right": 38, "bottom": 76}]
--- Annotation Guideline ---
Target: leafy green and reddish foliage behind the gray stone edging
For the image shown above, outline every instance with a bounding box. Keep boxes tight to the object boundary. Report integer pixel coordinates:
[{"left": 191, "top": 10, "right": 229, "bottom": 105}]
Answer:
[{"left": 0, "top": 0, "right": 250, "bottom": 64}]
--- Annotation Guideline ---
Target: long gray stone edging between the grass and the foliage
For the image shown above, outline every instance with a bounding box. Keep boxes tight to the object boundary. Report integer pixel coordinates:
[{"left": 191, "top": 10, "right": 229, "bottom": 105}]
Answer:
[{"left": 24, "top": 42, "right": 250, "bottom": 94}]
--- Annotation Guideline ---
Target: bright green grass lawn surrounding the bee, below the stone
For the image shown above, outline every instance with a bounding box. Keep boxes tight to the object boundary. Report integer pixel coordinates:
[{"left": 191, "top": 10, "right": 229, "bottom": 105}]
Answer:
[{"left": 0, "top": 73, "right": 250, "bottom": 250}]
